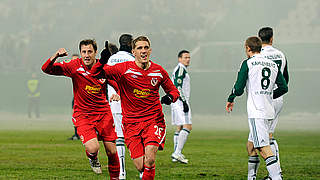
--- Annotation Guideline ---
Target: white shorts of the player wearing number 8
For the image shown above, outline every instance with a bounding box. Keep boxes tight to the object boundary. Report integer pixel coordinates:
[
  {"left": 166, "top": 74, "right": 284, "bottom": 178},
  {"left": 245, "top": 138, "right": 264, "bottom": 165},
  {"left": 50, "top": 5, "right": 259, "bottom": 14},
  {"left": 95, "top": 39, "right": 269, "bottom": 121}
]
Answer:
[{"left": 248, "top": 118, "right": 269, "bottom": 148}]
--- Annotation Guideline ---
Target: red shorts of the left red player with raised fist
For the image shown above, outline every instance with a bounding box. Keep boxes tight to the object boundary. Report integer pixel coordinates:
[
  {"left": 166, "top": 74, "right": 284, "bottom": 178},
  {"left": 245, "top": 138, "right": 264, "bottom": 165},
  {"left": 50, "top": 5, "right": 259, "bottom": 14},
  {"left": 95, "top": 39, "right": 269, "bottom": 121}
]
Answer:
[{"left": 72, "top": 113, "right": 117, "bottom": 144}]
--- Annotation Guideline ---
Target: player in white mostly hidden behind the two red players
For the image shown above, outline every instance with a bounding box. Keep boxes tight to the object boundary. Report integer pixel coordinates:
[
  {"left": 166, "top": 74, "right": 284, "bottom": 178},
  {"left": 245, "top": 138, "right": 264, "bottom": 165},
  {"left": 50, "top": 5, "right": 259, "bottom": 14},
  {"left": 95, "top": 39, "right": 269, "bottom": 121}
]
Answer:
[{"left": 107, "top": 34, "right": 134, "bottom": 179}]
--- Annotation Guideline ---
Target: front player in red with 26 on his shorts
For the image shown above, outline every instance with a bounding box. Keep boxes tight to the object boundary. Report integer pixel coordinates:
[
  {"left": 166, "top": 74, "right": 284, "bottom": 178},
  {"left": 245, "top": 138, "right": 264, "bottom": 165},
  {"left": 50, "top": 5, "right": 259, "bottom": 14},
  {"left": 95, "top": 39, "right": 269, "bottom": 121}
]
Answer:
[{"left": 92, "top": 36, "right": 179, "bottom": 180}]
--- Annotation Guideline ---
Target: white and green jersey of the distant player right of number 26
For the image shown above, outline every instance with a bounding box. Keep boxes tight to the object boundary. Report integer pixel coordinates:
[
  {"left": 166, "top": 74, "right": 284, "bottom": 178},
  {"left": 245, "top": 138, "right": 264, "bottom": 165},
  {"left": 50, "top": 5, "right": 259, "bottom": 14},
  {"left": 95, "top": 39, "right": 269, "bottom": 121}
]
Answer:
[{"left": 171, "top": 63, "right": 190, "bottom": 102}]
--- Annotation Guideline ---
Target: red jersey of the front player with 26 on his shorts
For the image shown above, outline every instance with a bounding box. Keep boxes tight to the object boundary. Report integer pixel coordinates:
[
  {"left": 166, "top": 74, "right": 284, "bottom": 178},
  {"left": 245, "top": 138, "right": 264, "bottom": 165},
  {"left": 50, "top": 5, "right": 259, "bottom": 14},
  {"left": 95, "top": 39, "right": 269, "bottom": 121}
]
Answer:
[{"left": 92, "top": 61, "right": 179, "bottom": 123}]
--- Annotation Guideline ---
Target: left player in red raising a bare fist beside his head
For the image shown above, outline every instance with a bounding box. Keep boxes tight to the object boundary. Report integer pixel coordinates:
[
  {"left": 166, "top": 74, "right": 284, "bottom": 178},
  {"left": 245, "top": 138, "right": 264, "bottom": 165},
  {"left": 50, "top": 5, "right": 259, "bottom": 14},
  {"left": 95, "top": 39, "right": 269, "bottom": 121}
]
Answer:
[{"left": 42, "top": 39, "right": 120, "bottom": 180}]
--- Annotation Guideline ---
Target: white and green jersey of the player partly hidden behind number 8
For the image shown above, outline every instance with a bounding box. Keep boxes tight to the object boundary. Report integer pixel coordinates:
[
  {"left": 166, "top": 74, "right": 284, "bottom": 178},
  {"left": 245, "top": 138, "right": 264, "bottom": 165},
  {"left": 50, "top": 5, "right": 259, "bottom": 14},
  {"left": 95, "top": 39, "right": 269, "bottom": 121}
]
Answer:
[{"left": 260, "top": 45, "right": 289, "bottom": 100}]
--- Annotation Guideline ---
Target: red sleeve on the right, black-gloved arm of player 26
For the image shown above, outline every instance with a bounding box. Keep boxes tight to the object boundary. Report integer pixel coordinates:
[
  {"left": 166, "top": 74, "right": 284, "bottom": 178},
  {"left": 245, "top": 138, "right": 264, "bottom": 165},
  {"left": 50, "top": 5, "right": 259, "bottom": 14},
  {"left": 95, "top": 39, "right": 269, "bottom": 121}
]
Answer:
[{"left": 161, "top": 69, "right": 180, "bottom": 102}]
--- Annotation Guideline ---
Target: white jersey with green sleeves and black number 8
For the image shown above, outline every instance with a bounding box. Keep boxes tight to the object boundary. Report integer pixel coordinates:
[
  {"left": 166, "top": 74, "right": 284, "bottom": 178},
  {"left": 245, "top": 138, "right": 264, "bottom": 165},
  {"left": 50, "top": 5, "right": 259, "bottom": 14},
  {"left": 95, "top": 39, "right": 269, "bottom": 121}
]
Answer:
[{"left": 228, "top": 54, "right": 288, "bottom": 119}]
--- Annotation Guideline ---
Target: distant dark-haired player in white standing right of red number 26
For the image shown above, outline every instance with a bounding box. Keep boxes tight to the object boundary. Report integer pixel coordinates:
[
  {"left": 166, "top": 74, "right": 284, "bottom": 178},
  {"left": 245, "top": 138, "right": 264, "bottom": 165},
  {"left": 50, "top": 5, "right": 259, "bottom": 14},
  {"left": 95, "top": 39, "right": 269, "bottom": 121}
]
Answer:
[{"left": 171, "top": 50, "right": 192, "bottom": 164}]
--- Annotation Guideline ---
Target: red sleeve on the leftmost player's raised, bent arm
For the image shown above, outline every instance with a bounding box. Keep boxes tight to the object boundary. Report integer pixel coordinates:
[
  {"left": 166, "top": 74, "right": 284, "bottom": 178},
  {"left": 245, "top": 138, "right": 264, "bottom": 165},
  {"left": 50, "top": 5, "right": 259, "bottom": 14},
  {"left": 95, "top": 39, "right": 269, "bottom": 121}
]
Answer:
[{"left": 41, "top": 58, "right": 72, "bottom": 77}]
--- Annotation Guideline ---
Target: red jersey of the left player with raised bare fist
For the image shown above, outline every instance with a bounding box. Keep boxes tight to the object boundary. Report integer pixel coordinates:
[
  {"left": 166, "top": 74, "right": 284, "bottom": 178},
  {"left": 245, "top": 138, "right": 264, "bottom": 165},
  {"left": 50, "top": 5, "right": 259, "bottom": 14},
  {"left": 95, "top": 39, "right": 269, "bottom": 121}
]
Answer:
[{"left": 42, "top": 59, "right": 111, "bottom": 114}]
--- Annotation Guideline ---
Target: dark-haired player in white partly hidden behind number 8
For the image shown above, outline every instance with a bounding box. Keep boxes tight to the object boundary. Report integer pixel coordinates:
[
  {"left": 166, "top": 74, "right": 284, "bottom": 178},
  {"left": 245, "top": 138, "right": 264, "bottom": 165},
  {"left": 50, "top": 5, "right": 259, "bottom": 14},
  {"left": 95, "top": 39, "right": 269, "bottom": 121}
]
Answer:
[{"left": 258, "top": 27, "right": 289, "bottom": 179}]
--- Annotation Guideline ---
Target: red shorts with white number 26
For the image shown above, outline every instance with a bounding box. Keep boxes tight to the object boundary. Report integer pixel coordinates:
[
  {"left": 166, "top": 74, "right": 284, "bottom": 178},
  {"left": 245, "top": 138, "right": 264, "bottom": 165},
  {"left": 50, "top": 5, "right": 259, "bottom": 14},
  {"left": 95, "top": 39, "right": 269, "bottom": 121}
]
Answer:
[{"left": 123, "top": 120, "right": 166, "bottom": 159}]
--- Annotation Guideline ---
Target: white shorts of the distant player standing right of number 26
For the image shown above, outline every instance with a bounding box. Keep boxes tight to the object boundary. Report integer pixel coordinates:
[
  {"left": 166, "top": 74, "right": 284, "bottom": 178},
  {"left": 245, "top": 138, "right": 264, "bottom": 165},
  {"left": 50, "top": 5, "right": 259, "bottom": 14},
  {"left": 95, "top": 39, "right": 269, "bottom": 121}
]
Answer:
[{"left": 171, "top": 106, "right": 192, "bottom": 126}]
